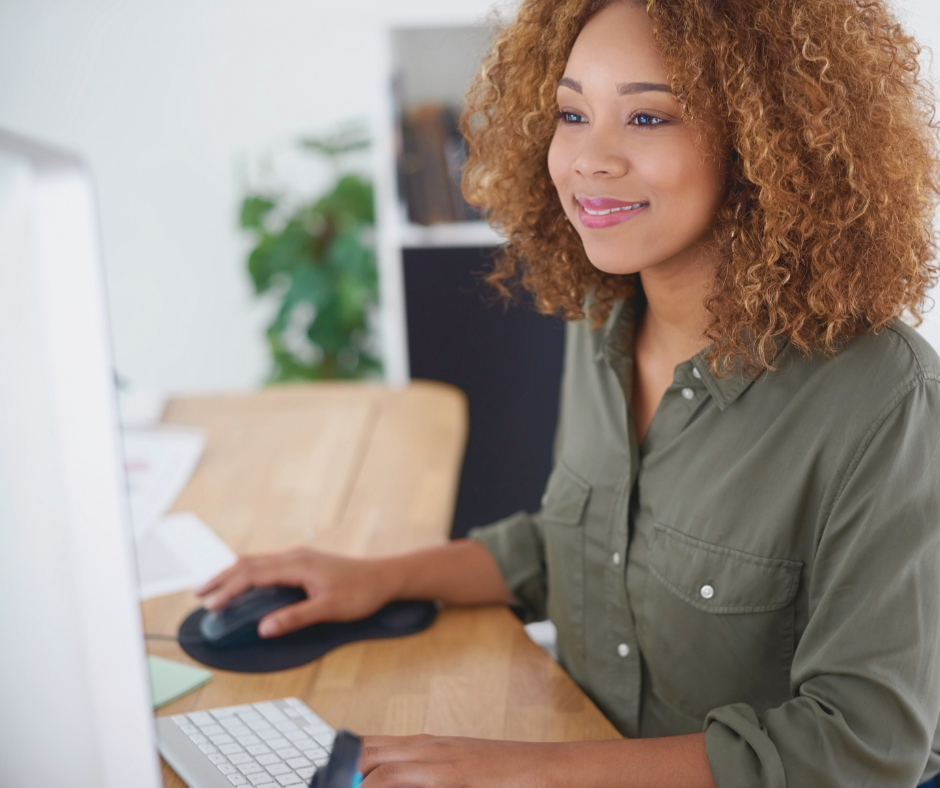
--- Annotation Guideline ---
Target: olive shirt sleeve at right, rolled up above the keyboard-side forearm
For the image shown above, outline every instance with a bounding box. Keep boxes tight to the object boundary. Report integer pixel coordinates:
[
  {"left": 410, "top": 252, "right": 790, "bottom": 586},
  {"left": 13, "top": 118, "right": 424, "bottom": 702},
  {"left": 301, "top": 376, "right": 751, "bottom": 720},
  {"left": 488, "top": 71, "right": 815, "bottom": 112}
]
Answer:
[{"left": 704, "top": 378, "right": 940, "bottom": 788}]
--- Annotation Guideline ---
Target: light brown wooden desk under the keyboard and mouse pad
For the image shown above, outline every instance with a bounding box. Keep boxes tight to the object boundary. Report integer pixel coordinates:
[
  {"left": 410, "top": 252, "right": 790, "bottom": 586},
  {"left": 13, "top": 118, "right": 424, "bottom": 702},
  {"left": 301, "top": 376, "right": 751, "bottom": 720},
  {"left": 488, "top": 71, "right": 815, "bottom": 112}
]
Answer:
[{"left": 143, "top": 383, "right": 618, "bottom": 788}]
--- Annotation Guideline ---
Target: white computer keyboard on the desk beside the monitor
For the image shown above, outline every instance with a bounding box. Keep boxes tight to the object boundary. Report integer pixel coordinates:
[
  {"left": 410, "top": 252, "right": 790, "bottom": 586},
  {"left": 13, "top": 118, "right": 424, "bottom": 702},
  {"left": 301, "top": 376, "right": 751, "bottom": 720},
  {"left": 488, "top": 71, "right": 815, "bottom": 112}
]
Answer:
[{"left": 157, "top": 698, "right": 336, "bottom": 788}]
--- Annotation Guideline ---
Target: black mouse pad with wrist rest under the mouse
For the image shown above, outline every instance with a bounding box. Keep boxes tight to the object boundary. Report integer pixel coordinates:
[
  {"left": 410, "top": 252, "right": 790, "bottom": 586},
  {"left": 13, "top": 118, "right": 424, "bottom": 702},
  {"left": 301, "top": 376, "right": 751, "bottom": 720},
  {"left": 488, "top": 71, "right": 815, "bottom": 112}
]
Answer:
[{"left": 179, "top": 602, "right": 437, "bottom": 673}]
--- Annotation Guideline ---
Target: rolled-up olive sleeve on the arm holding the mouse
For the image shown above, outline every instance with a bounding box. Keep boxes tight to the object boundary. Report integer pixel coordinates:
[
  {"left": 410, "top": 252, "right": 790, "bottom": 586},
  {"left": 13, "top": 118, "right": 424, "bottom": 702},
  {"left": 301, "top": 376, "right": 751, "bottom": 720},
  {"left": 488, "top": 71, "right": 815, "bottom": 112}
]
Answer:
[{"left": 468, "top": 512, "right": 548, "bottom": 621}]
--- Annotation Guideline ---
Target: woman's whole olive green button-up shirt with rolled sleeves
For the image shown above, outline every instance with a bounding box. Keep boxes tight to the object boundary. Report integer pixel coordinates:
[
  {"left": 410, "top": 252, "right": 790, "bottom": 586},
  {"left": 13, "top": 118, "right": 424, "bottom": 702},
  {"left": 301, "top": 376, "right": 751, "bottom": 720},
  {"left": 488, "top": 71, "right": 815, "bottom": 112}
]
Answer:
[{"left": 471, "top": 305, "right": 940, "bottom": 788}]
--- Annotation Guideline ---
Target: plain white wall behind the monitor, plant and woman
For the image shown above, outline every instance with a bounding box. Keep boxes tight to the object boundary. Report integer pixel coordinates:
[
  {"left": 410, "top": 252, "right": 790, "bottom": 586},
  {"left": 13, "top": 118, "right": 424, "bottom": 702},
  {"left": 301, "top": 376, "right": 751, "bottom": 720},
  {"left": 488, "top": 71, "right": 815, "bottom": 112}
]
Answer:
[{"left": 0, "top": 0, "right": 940, "bottom": 391}]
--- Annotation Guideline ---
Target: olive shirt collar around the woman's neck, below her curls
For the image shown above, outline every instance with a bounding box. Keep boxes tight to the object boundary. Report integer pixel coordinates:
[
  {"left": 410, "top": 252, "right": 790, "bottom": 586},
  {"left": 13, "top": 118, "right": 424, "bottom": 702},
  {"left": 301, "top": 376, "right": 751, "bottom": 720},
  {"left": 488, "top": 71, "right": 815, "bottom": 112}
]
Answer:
[{"left": 594, "top": 299, "right": 764, "bottom": 411}]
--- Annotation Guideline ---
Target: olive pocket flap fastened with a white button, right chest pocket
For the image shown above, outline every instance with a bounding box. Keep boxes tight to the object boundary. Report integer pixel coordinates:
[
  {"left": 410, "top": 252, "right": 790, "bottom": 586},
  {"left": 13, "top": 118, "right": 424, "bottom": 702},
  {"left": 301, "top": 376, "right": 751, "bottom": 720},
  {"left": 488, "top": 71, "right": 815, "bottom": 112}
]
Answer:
[{"left": 649, "top": 523, "right": 803, "bottom": 613}]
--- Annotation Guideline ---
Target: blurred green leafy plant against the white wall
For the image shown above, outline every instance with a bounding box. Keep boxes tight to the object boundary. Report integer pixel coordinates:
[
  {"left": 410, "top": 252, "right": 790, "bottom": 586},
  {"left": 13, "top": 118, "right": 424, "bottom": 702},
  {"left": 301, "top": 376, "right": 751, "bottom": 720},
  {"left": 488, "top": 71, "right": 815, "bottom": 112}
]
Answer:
[{"left": 240, "top": 127, "right": 381, "bottom": 382}]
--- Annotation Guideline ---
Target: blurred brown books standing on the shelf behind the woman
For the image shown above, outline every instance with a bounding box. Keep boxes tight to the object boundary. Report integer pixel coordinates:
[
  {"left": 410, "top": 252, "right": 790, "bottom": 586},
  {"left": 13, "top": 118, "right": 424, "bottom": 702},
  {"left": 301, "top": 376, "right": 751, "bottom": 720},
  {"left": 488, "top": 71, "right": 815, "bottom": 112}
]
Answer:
[{"left": 398, "top": 104, "right": 480, "bottom": 225}]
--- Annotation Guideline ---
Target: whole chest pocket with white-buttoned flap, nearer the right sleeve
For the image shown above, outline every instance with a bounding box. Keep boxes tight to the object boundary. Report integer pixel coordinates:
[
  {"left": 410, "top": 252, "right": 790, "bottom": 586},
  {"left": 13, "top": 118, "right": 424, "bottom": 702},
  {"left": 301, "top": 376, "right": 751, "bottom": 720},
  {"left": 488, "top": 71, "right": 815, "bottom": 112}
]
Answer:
[{"left": 638, "top": 524, "right": 802, "bottom": 720}]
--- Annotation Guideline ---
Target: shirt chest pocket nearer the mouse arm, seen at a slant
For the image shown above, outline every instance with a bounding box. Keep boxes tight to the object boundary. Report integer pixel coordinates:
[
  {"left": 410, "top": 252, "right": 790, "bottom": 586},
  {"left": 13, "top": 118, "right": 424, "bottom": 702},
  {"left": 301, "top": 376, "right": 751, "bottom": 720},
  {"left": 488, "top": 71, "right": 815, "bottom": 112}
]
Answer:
[{"left": 538, "top": 461, "right": 591, "bottom": 665}]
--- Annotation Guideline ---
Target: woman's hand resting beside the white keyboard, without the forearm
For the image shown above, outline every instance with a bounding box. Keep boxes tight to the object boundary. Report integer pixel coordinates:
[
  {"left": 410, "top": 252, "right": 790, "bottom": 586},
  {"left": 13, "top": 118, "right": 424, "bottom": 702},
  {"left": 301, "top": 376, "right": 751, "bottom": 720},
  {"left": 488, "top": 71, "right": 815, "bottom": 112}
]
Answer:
[{"left": 361, "top": 736, "right": 563, "bottom": 788}]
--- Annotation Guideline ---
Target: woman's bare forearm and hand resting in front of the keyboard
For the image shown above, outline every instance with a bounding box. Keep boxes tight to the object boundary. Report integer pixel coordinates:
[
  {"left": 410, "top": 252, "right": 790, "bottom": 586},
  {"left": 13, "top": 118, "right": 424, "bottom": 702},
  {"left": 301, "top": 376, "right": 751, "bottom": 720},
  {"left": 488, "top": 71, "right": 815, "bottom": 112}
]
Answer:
[{"left": 362, "top": 733, "right": 715, "bottom": 788}]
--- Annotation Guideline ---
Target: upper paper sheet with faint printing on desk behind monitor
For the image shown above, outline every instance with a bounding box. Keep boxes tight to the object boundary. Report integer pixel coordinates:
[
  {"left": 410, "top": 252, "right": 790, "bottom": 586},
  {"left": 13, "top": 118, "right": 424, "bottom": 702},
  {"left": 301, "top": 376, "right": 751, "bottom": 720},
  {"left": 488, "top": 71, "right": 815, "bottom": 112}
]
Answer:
[{"left": 122, "top": 427, "right": 206, "bottom": 540}]
